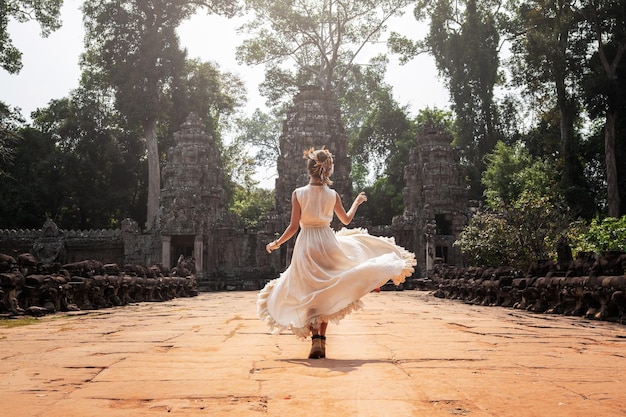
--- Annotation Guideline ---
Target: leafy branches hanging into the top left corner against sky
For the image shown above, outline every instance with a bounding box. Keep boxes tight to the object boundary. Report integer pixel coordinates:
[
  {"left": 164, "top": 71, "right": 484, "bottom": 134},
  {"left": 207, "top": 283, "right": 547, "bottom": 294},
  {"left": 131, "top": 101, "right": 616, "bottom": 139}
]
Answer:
[{"left": 0, "top": 0, "right": 63, "bottom": 74}]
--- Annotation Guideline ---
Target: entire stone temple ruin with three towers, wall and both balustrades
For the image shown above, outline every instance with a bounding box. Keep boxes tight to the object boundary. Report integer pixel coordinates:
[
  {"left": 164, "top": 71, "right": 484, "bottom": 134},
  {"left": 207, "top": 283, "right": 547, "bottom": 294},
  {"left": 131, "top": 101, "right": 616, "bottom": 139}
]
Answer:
[{"left": 0, "top": 87, "right": 626, "bottom": 323}]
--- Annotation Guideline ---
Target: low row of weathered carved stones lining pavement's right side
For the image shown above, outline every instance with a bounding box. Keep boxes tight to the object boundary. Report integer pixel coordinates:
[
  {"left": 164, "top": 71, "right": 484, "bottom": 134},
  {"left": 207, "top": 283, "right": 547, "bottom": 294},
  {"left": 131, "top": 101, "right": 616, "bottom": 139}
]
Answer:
[{"left": 428, "top": 251, "right": 626, "bottom": 324}]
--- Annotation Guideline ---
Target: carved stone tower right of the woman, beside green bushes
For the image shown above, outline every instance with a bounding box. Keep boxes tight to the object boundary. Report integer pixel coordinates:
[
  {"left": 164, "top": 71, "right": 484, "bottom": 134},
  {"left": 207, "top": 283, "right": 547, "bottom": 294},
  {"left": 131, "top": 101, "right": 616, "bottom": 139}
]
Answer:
[{"left": 403, "top": 126, "right": 468, "bottom": 270}]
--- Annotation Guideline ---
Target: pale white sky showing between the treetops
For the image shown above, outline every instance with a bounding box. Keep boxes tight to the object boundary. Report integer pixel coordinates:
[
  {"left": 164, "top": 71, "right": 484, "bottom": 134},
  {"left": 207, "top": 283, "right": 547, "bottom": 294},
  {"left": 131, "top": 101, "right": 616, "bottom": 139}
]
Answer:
[{"left": 0, "top": 0, "right": 449, "bottom": 120}]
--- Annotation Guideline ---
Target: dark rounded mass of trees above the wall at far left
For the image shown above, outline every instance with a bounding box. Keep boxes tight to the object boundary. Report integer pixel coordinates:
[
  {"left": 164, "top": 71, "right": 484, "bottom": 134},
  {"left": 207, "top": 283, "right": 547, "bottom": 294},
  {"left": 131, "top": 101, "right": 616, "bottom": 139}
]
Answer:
[{"left": 0, "top": 88, "right": 145, "bottom": 229}]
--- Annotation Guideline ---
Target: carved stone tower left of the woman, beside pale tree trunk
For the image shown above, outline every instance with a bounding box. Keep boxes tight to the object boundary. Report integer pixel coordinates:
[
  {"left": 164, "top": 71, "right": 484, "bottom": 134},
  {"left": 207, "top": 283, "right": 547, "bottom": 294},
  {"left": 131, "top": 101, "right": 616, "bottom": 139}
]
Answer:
[{"left": 158, "top": 113, "right": 226, "bottom": 271}]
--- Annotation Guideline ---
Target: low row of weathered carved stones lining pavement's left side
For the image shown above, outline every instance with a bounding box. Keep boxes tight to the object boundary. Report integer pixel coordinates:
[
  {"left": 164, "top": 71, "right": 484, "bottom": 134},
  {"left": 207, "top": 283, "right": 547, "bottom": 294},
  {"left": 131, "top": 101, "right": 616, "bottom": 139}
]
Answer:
[{"left": 0, "top": 253, "right": 198, "bottom": 316}]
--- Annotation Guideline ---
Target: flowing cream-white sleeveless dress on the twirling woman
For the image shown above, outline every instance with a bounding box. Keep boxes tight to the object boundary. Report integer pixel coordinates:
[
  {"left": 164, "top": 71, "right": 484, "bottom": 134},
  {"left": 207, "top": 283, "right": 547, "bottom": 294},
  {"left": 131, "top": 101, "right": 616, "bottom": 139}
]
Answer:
[{"left": 257, "top": 185, "right": 416, "bottom": 338}]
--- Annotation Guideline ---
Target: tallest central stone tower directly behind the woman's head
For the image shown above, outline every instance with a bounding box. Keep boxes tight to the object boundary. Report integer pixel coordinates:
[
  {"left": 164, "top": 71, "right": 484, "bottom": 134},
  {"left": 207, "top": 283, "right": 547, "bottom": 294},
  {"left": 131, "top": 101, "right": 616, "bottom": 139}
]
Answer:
[{"left": 275, "top": 87, "right": 352, "bottom": 215}]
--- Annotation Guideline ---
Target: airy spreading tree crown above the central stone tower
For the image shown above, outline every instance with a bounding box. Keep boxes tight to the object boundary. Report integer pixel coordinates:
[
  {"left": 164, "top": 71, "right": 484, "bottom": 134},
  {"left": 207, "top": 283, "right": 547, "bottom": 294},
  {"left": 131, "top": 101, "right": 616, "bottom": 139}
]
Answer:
[{"left": 237, "top": 0, "right": 412, "bottom": 105}]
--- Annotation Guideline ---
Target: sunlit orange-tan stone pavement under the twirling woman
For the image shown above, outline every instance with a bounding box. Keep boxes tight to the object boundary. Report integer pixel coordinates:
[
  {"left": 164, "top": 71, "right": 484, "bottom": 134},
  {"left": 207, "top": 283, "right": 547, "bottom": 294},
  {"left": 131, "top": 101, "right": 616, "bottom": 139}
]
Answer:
[{"left": 0, "top": 291, "right": 626, "bottom": 417}]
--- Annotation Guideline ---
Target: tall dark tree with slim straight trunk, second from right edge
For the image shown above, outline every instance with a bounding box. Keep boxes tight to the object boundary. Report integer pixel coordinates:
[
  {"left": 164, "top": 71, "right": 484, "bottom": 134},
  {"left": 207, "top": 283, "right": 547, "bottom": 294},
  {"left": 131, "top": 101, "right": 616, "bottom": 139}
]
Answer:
[{"left": 510, "top": 0, "right": 588, "bottom": 211}]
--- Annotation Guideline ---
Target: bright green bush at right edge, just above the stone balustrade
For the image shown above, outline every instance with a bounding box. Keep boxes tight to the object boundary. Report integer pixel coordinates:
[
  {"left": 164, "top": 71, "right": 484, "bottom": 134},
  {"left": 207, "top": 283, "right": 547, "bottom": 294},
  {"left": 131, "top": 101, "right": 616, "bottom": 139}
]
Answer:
[{"left": 574, "top": 216, "right": 626, "bottom": 253}]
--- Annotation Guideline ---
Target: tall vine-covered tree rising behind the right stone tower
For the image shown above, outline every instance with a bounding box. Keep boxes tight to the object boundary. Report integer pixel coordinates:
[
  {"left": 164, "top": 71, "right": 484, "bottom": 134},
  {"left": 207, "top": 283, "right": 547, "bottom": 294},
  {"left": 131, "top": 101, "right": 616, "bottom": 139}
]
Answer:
[{"left": 390, "top": 0, "right": 506, "bottom": 198}]
